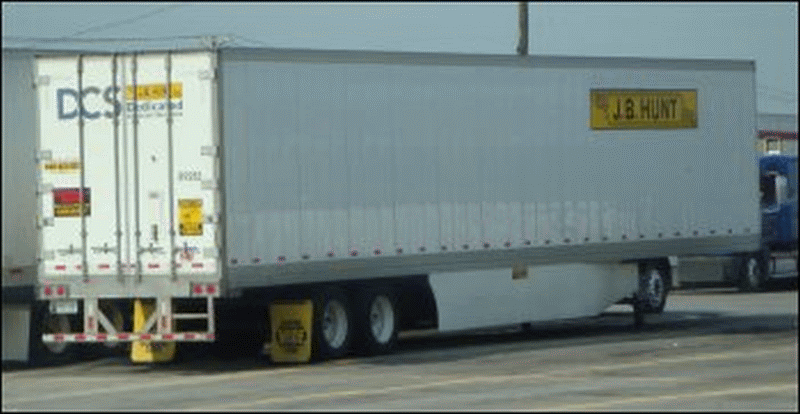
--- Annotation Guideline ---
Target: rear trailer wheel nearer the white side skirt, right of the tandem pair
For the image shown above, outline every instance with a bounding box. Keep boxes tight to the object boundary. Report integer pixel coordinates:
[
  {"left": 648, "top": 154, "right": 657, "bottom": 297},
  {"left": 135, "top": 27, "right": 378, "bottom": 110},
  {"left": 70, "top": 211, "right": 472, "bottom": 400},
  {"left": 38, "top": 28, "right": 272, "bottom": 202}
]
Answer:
[{"left": 354, "top": 287, "right": 400, "bottom": 355}]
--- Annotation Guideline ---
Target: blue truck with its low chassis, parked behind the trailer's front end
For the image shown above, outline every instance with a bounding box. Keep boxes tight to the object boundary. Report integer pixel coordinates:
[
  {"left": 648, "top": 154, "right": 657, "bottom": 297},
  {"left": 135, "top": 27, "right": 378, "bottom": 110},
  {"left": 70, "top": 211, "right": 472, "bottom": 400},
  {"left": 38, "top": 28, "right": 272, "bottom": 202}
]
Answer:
[{"left": 675, "top": 154, "right": 798, "bottom": 292}]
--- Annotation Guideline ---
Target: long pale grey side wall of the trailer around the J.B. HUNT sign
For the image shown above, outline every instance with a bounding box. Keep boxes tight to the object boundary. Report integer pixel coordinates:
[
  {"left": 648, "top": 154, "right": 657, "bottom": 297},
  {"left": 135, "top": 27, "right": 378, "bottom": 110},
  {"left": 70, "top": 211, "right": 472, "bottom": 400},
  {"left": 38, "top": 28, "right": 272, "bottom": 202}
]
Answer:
[{"left": 220, "top": 50, "right": 760, "bottom": 286}]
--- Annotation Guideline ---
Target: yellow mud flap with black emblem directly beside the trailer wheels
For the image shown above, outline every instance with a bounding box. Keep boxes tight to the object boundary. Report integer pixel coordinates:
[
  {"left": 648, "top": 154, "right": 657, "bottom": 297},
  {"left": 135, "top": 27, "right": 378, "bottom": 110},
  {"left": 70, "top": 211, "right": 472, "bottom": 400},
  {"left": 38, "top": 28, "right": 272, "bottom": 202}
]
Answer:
[{"left": 269, "top": 300, "right": 313, "bottom": 362}]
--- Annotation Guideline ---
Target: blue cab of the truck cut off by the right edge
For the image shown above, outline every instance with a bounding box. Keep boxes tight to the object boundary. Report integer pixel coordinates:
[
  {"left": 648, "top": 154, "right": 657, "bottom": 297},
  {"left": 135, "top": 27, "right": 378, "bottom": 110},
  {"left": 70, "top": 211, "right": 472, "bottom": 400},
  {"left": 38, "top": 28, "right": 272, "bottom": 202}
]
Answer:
[{"left": 759, "top": 155, "right": 797, "bottom": 252}]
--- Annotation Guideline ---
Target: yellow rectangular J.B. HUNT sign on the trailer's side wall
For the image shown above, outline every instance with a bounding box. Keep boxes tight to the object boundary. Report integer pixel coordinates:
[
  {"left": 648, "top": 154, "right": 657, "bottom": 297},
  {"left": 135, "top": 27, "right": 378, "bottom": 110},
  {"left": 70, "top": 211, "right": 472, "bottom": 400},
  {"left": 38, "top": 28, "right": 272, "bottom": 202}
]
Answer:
[{"left": 589, "top": 89, "right": 697, "bottom": 129}]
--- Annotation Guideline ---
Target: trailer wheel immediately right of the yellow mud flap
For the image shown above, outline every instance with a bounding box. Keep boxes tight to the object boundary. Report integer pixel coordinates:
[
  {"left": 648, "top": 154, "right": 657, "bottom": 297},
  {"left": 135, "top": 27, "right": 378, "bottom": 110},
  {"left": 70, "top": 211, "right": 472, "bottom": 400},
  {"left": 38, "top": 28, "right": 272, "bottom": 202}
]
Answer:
[{"left": 311, "top": 288, "right": 354, "bottom": 360}]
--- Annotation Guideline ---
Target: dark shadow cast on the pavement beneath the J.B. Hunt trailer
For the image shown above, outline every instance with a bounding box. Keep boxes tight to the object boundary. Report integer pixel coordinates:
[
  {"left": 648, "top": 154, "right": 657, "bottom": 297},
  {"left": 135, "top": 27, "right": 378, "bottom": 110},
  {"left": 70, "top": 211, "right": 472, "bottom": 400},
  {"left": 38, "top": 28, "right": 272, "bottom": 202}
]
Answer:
[{"left": 87, "top": 311, "right": 797, "bottom": 376}]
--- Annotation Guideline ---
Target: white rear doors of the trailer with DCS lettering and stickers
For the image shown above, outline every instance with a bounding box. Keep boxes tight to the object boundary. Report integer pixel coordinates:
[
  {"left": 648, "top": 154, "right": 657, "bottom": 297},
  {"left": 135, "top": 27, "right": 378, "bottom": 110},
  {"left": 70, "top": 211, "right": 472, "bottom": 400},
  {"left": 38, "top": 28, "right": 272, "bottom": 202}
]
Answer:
[{"left": 36, "top": 53, "right": 219, "bottom": 296}]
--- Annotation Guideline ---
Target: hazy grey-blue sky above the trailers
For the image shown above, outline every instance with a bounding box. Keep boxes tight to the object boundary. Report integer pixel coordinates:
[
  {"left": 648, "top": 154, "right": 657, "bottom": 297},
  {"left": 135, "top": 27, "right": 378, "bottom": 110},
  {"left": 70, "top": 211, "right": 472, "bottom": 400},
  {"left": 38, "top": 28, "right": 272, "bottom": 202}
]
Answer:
[{"left": 2, "top": 2, "right": 798, "bottom": 114}]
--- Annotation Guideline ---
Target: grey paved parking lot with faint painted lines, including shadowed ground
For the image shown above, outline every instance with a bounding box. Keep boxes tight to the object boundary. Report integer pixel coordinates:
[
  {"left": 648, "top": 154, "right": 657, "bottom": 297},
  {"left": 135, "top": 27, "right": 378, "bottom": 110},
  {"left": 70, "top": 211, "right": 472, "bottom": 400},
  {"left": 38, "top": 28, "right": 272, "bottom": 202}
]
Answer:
[{"left": 2, "top": 289, "right": 798, "bottom": 411}]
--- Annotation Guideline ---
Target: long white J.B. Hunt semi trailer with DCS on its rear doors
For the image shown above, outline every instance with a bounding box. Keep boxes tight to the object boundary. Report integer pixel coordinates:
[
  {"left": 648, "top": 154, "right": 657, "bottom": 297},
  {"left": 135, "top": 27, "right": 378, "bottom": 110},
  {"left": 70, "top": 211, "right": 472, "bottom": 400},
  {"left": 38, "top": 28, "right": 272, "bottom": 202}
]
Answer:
[{"left": 3, "top": 48, "right": 760, "bottom": 358}]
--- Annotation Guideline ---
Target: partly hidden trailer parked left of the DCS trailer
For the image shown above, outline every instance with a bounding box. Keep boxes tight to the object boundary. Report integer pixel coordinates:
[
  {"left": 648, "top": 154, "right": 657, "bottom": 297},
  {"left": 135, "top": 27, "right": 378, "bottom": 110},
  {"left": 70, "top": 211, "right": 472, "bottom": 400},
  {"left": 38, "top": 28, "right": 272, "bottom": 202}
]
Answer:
[{"left": 2, "top": 48, "right": 92, "bottom": 364}]
